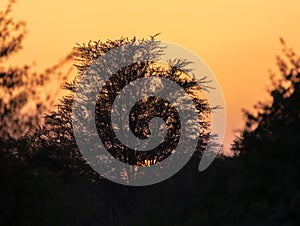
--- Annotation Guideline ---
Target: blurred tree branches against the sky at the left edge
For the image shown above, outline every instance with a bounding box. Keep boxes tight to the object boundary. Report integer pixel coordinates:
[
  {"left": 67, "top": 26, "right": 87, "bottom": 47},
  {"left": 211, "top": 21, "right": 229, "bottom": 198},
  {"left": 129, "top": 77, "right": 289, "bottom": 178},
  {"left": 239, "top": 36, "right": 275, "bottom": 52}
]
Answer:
[{"left": 0, "top": 0, "right": 71, "bottom": 139}]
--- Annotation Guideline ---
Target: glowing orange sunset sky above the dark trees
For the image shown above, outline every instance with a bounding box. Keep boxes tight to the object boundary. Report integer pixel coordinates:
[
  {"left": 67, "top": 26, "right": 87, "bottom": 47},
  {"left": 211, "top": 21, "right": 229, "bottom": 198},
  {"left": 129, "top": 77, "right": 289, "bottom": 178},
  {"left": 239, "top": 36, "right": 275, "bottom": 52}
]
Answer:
[{"left": 4, "top": 0, "right": 300, "bottom": 154}]
